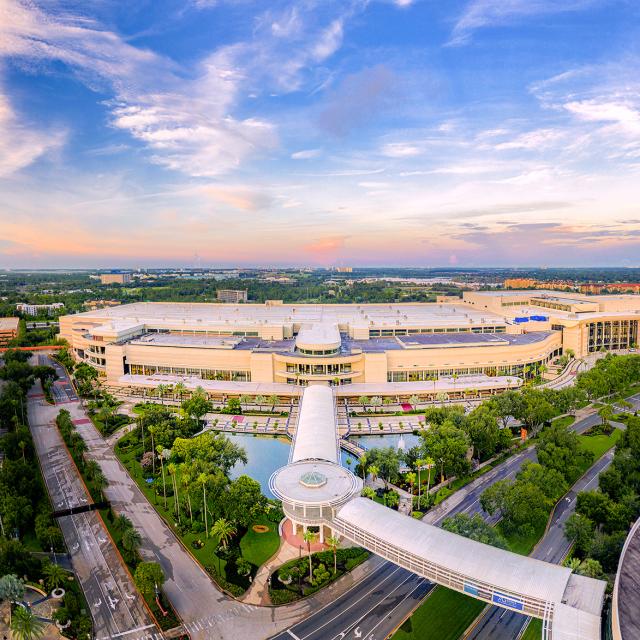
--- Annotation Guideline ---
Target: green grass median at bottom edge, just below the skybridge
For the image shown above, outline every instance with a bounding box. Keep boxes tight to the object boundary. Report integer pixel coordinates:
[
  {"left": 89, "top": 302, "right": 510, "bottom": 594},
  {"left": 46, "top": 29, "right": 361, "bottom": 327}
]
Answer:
[{"left": 393, "top": 587, "right": 485, "bottom": 640}]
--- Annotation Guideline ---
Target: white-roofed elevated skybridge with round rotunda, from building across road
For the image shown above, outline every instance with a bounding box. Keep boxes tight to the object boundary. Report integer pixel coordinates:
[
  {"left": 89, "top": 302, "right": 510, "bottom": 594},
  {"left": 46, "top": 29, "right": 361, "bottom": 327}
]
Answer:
[{"left": 269, "top": 386, "right": 606, "bottom": 640}]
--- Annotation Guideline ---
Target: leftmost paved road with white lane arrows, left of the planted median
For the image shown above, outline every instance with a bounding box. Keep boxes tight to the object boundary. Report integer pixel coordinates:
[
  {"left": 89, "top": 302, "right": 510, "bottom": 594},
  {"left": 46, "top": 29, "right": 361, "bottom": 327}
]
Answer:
[{"left": 28, "top": 383, "right": 157, "bottom": 640}]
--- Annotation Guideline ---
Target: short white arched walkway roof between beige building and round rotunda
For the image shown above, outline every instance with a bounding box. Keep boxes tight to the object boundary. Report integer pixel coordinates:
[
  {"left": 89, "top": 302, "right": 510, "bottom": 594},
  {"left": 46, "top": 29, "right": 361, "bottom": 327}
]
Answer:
[{"left": 289, "top": 385, "right": 340, "bottom": 464}]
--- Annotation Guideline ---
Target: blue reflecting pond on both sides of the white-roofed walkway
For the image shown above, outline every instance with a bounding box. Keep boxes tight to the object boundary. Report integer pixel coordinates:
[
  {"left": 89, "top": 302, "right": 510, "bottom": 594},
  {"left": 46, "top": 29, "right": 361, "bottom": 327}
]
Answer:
[{"left": 225, "top": 433, "right": 420, "bottom": 498}]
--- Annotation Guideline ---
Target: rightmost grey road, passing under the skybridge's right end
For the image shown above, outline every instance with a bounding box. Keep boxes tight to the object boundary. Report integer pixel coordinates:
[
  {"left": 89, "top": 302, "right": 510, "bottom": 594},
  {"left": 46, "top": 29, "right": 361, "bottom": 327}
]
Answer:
[{"left": 465, "top": 450, "right": 614, "bottom": 640}]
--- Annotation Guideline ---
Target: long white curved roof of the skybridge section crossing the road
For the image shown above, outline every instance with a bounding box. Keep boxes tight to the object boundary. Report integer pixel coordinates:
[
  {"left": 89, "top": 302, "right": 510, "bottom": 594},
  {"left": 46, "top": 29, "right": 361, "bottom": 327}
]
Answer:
[{"left": 336, "top": 498, "right": 571, "bottom": 603}]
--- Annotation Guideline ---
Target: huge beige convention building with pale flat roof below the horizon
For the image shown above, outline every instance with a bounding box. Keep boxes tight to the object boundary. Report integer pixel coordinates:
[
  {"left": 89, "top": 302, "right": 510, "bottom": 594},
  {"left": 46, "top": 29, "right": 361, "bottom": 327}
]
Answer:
[{"left": 60, "top": 291, "right": 640, "bottom": 397}]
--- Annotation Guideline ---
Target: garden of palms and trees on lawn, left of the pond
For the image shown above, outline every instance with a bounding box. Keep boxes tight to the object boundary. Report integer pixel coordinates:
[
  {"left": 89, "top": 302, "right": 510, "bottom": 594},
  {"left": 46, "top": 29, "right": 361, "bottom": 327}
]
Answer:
[{"left": 115, "top": 394, "right": 283, "bottom": 596}]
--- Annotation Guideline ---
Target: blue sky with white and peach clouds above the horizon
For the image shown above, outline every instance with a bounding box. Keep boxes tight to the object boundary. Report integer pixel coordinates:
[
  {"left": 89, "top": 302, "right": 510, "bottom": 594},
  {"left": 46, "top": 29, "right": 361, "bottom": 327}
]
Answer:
[{"left": 0, "top": 0, "right": 640, "bottom": 267}]
